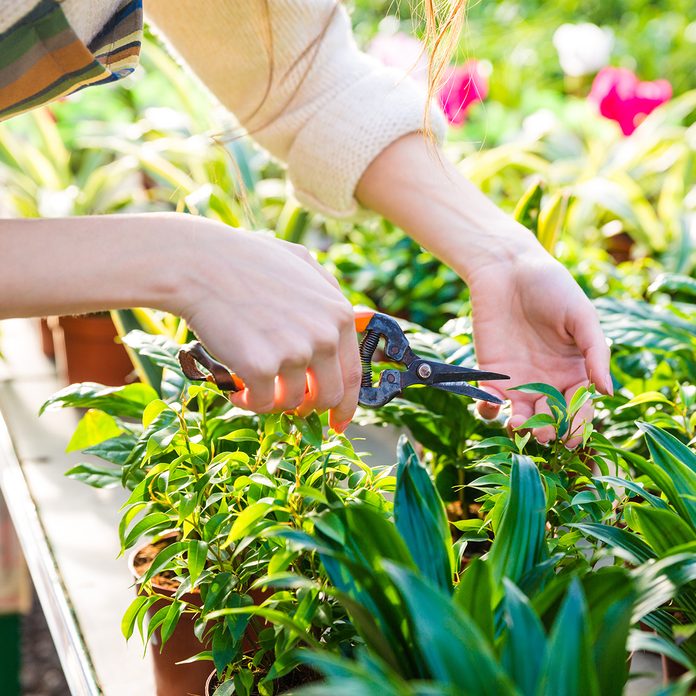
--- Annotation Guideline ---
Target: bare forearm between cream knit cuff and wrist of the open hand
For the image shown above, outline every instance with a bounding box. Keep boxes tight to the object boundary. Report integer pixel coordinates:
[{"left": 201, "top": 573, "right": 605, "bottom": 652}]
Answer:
[{"left": 357, "top": 133, "right": 541, "bottom": 280}]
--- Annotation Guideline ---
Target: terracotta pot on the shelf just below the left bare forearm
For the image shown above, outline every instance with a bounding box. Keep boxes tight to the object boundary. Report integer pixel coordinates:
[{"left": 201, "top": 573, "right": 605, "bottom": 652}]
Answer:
[{"left": 53, "top": 314, "right": 133, "bottom": 386}]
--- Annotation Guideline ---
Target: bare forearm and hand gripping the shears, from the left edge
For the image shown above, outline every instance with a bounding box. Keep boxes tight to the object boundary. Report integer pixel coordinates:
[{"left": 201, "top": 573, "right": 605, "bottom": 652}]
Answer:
[{"left": 0, "top": 213, "right": 360, "bottom": 430}]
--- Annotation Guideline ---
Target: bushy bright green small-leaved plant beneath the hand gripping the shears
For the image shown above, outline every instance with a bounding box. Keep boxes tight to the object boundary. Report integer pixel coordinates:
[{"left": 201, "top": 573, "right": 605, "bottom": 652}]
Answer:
[{"left": 44, "top": 333, "right": 393, "bottom": 694}]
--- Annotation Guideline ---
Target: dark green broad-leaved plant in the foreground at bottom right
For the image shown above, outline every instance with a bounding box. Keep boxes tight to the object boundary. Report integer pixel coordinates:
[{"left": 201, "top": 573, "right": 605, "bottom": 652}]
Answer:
[{"left": 267, "top": 441, "right": 696, "bottom": 696}]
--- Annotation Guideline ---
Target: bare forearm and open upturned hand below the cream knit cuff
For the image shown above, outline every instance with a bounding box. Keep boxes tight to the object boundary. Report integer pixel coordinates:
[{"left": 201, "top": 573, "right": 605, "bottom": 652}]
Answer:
[{"left": 357, "top": 133, "right": 611, "bottom": 446}]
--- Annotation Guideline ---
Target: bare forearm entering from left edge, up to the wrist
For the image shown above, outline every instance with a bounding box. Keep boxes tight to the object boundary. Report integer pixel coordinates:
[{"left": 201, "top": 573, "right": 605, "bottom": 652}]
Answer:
[{"left": 0, "top": 214, "right": 190, "bottom": 319}]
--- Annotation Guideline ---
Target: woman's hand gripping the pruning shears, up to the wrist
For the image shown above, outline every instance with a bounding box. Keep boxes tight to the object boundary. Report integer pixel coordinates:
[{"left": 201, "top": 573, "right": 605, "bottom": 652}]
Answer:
[{"left": 178, "top": 218, "right": 360, "bottom": 431}]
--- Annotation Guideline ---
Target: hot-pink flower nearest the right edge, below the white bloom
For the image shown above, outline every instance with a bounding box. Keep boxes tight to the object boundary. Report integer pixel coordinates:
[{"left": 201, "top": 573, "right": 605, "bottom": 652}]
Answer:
[{"left": 589, "top": 67, "right": 672, "bottom": 135}]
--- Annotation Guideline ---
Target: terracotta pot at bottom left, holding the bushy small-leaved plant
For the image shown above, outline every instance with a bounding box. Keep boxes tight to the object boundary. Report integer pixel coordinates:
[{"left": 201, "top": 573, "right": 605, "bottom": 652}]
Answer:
[{"left": 129, "top": 533, "right": 210, "bottom": 696}]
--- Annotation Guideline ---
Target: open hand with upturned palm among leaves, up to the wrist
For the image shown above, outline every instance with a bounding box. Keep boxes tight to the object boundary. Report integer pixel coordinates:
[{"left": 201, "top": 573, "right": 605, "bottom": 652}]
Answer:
[{"left": 467, "top": 248, "right": 612, "bottom": 447}]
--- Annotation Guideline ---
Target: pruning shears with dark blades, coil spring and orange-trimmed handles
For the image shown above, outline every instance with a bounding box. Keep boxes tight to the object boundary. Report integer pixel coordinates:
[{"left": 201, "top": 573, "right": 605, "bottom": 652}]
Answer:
[{"left": 179, "top": 310, "right": 509, "bottom": 408}]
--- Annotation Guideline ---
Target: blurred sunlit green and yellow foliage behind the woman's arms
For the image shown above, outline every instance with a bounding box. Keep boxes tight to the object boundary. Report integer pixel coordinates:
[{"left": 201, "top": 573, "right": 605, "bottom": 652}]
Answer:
[{"left": 0, "top": 0, "right": 696, "bottom": 340}]
